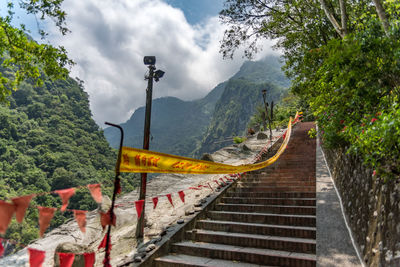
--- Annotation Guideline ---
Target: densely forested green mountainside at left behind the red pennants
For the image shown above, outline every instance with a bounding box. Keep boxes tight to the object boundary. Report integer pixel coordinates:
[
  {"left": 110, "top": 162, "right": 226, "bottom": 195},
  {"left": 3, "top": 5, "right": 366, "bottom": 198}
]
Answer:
[{"left": 0, "top": 73, "right": 135, "bottom": 247}]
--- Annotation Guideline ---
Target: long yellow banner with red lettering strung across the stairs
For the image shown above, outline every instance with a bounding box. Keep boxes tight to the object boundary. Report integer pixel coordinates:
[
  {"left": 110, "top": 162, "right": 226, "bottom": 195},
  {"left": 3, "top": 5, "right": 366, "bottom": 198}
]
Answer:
[{"left": 120, "top": 114, "right": 298, "bottom": 174}]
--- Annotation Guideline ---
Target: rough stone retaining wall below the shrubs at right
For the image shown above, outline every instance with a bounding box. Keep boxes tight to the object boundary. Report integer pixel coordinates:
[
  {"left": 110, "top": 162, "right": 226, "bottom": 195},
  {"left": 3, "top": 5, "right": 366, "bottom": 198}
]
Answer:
[{"left": 324, "top": 149, "right": 400, "bottom": 266}]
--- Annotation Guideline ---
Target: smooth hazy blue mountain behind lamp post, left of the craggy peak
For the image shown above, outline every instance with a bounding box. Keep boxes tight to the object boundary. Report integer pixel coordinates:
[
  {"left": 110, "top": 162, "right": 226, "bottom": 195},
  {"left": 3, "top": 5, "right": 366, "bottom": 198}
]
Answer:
[{"left": 104, "top": 83, "right": 226, "bottom": 156}]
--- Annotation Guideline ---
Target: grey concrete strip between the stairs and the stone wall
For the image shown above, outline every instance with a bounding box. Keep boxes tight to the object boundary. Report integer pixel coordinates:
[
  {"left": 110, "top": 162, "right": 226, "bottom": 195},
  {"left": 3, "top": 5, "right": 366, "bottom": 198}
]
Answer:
[{"left": 316, "top": 137, "right": 363, "bottom": 267}]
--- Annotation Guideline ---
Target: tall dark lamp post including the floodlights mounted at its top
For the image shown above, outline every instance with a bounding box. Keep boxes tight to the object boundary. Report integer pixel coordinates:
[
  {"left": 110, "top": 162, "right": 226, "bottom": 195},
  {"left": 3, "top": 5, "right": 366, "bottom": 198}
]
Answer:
[{"left": 136, "top": 56, "right": 165, "bottom": 239}]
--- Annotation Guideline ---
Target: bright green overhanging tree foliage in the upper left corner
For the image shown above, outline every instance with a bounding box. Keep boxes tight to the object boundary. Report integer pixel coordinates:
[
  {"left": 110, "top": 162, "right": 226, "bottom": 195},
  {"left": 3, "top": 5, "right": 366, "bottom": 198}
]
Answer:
[{"left": 0, "top": 0, "right": 73, "bottom": 102}]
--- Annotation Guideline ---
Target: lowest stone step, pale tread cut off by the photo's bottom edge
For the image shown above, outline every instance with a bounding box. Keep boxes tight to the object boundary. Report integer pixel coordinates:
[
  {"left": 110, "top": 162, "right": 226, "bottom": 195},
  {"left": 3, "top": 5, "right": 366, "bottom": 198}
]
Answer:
[{"left": 154, "top": 254, "right": 265, "bottom": 267}]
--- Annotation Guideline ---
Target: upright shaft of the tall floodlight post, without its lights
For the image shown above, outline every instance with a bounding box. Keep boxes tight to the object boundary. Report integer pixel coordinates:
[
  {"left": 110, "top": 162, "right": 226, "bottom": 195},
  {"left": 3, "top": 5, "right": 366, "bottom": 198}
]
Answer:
[{"left": 136, "top": 65, "right": 156, "bottom": 239}]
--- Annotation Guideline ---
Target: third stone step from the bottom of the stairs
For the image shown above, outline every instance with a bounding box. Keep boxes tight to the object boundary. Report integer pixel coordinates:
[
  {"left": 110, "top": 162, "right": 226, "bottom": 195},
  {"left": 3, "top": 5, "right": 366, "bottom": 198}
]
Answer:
[{"left": 185, "top": 229, "right": 315, "bottom": 253}]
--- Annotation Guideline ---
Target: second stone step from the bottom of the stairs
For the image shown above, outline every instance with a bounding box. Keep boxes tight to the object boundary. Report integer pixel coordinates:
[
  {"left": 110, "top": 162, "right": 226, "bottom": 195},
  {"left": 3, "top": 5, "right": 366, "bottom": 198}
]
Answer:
[{"left": 172, "top": 241, "right": 316, "bottom": 267}]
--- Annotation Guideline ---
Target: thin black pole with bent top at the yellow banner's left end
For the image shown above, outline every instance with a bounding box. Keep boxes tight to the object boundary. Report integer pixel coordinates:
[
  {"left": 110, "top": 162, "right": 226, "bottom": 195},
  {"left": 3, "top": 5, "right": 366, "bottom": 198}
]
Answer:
[{"left": 104, "top": 122, "right": 124, "bottom": 267}]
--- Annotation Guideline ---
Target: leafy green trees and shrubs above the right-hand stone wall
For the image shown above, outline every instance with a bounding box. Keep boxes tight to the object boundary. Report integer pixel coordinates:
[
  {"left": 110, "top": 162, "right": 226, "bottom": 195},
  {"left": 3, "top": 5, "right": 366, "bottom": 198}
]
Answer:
[{"left": 220, "top": 0, "right": 400, "bottom": 180}]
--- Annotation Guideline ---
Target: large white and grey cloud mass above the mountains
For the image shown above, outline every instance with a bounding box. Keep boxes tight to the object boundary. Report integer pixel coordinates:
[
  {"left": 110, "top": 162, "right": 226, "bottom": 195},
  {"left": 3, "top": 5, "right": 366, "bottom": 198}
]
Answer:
[{"left": 51, "top": 0, "right": 276, "bottom": 127}]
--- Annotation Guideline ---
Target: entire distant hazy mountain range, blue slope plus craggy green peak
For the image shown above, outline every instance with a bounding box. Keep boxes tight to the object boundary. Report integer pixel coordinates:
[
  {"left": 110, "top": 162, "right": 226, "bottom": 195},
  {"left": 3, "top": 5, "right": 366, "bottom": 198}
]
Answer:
[{"left": 104, "top": 55, "right": 290, "bottom": 156}]
